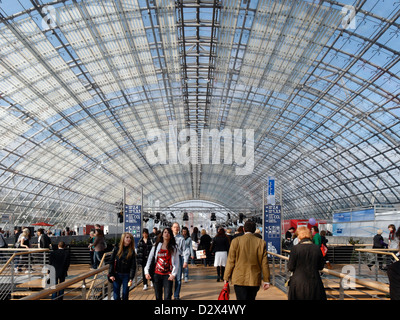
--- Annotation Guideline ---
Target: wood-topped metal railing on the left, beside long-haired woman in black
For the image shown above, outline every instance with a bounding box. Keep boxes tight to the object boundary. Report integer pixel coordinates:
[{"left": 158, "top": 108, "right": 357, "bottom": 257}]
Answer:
[{"left": 0, "top": 248, "right": 142, "bottom": 300}]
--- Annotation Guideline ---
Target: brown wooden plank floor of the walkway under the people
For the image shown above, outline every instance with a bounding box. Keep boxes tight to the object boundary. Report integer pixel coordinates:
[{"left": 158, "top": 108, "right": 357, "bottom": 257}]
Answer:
[{"left": 129, "top": 265, "right": 287, "bottom": 300}]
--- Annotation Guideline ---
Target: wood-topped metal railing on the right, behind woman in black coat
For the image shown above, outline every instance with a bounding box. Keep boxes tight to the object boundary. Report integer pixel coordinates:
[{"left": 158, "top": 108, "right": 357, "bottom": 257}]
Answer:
[{"left": 268, "top": 252, "right": 389, "bottom": 300}]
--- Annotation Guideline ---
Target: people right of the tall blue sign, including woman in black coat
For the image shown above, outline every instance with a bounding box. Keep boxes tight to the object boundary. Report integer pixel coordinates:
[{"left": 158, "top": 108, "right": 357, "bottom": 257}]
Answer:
[{"left": 284, "top": 224, "right": 400, "bottom": 300}]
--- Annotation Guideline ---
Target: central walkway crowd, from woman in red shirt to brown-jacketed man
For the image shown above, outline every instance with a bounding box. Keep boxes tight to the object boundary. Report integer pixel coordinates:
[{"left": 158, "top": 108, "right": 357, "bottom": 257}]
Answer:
[{"left": 136, "top": 221, "right": 269, "bottom": 300}]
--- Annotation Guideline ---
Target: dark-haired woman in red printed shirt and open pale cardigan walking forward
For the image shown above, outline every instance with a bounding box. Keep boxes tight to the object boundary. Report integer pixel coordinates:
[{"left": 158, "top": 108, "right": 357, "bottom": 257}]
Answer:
[{"left": 144, "top": 228, "right": 179, "bottom": 300}]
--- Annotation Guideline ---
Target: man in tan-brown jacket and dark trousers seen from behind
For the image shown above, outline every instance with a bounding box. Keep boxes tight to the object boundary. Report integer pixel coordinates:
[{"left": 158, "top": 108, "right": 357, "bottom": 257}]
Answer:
[{"left": 224, "top": 221, "right": 269, "bottom": 300}]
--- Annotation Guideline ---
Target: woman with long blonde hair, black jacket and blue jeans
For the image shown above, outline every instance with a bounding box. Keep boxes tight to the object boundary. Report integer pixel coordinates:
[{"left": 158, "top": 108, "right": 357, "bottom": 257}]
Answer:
[{"left": 108, "top": 232, "right": 136, "bottom": 300}]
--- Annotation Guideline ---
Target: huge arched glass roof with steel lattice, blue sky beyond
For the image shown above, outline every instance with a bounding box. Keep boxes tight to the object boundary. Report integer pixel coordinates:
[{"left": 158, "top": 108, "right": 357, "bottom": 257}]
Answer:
[{"left": 0, "top": 0, "right": 400, "bottom": 229}]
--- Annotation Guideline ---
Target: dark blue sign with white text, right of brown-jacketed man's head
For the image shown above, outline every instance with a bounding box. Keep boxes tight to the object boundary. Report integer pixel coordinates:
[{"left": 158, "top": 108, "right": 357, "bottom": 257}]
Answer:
[{"left": 264, "top": 204, "right": 282, "bottom": 254}]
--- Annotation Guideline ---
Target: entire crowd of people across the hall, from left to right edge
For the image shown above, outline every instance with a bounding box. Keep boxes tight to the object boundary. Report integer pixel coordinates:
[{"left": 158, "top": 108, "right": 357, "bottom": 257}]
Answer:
[{"left": 0, "top": 221, "right": 400, "bottom": 300}]
